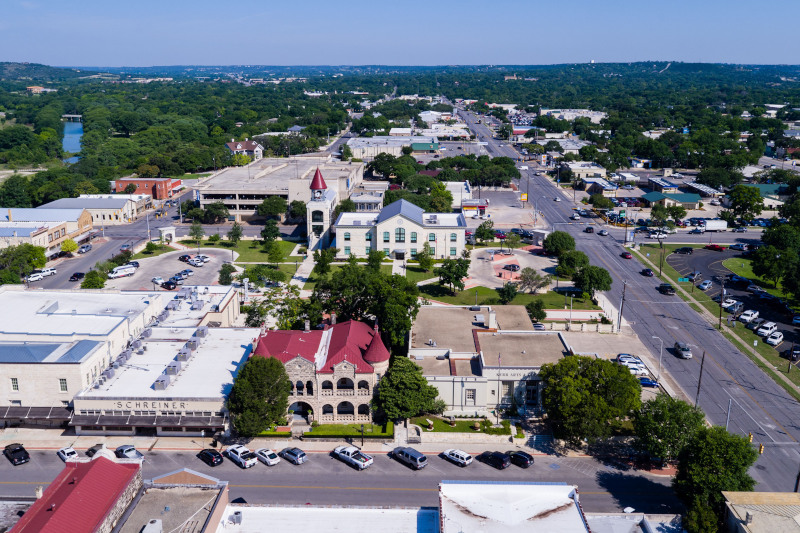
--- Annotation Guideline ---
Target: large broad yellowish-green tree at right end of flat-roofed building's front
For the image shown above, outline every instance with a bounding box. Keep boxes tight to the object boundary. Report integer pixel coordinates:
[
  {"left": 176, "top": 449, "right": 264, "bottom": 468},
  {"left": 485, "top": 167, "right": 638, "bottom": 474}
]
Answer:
[{"left": 539, "top": 356, "right": 642, "bottom": 444}]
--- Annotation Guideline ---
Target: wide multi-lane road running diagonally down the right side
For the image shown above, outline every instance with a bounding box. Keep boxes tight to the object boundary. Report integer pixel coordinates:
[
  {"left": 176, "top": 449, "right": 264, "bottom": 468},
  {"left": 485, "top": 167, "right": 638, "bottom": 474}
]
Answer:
[{"left": 459, "top": 110, "right": 800, "bottom": 491}]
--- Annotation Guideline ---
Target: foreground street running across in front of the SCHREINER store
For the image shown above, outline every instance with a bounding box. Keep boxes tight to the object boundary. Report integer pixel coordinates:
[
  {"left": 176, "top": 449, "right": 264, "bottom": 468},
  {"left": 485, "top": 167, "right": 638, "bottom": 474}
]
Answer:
[{"left": 0, "top": 444, "right": 681, "bottom": 513}]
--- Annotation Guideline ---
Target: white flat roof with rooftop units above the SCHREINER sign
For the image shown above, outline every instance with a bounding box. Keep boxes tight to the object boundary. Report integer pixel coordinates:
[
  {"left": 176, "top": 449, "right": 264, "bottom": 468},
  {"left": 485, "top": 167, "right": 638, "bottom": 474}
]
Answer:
[{"left": 76, "top": 327, "right": 255, "bottom": 400}]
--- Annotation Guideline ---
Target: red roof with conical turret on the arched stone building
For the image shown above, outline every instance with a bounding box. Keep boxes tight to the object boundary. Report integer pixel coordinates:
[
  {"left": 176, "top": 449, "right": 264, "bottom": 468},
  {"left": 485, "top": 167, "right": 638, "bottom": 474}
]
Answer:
[{"left": 254, "top": 320, "right": 388, "bottom": 374}]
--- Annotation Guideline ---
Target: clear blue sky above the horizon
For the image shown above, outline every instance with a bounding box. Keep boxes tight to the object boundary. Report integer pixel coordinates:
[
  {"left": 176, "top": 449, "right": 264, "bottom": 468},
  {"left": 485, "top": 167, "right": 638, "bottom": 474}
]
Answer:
[{"left": 0, "top": 0, "right": 800, "bottom": 66}]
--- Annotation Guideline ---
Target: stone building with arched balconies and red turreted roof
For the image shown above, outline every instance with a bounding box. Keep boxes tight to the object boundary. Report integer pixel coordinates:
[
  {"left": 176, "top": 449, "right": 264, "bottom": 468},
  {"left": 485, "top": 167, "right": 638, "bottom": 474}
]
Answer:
[{"left": 254, "top": 320, "right": 389, "bottom": 423}]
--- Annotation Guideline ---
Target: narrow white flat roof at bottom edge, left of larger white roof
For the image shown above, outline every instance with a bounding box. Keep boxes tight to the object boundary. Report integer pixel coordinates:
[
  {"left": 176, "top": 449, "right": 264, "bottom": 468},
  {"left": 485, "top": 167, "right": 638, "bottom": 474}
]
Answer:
[{"left": 216, "top": 505, "right": 438, "bottom": 533}]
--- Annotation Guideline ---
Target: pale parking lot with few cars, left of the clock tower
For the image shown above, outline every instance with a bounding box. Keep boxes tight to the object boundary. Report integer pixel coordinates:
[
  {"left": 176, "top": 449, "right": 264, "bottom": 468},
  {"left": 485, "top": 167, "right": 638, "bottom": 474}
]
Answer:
[{"left": 101, "top": 248, "right": 231, "bottom": 290}]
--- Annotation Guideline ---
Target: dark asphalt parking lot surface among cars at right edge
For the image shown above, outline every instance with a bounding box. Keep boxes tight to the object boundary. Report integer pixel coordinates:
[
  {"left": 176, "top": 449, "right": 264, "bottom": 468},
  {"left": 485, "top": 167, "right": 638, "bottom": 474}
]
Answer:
[{"left": 666, "top": 248, "right": 800, "bottom": 352}]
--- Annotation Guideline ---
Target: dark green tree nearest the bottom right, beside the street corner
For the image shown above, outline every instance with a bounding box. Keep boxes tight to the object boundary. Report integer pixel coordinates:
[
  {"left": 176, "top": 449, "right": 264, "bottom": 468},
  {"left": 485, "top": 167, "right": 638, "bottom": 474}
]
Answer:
[{"left": 672, "top": 426, "right": 758, "bottom": 517}]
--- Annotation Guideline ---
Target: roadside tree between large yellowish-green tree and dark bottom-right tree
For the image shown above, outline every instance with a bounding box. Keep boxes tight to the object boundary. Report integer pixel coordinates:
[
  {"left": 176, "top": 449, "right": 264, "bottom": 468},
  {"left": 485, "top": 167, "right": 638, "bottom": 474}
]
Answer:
[{"left": 633, "top": 394, "right": 705, "bottom": 463}]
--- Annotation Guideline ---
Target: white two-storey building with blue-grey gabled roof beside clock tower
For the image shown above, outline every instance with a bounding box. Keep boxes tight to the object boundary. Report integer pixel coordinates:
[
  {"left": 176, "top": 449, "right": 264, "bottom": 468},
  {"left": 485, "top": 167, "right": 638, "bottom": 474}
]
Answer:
[{"left": 332, "top": 200, "right": 467, "bottom": 259}]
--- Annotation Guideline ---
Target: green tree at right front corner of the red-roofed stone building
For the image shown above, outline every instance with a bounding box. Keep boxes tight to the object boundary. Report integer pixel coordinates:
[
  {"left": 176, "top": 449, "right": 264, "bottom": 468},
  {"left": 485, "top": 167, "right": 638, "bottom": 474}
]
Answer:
[{"left": 374, "top": 357, "right": 439, "bottom": 421}]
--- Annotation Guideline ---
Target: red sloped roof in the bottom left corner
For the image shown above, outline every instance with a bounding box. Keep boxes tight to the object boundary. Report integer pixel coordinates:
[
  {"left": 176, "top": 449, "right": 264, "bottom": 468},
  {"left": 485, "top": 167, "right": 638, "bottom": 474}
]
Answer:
[{"left": 14, "top": 457, "right": 141, "bottom": 533}]
